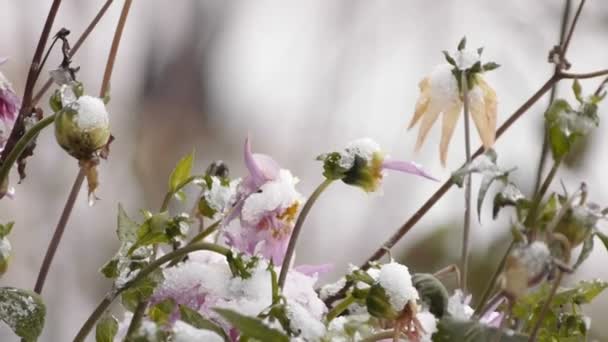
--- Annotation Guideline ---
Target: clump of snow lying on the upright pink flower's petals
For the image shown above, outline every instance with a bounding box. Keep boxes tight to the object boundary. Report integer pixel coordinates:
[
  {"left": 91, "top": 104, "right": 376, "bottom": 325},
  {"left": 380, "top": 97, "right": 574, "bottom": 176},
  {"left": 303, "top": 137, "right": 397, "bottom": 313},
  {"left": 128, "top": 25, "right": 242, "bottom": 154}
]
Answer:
[{"left": 241, "top": 169, "right": 303, "bottom": 225}]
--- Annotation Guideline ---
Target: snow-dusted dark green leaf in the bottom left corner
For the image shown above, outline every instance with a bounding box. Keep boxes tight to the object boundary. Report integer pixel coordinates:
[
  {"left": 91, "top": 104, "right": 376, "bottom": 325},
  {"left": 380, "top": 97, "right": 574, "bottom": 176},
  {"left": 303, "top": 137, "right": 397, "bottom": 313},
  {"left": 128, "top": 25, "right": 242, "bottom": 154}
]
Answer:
[{"left": 0, "top": 287, "right": 46, "bottom": 342}]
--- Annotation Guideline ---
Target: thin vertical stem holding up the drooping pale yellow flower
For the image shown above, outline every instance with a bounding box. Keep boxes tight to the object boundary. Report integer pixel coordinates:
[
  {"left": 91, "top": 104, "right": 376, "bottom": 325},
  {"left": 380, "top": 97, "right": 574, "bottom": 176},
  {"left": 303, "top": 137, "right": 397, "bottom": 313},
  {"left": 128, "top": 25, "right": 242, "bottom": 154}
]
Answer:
[{"left": 460, "top": 72, "right": 471, "bottom": 295}]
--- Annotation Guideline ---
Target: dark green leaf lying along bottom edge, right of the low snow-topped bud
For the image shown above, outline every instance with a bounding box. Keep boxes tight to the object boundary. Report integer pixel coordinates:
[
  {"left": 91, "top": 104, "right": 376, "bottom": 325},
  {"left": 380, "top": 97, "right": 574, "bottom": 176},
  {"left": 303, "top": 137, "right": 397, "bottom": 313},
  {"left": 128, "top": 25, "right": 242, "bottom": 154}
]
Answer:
[{"left": 432, "top": 315, "right": 528, "bottom": 342}]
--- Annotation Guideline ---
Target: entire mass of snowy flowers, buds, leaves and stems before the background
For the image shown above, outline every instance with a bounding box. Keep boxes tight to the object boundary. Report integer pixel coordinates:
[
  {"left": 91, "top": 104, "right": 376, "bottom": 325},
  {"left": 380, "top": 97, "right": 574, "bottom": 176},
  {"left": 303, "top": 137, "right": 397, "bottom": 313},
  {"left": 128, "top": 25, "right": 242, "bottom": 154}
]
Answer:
[{"left": 0, "top": 0, "right": 608, "bottom": 342}]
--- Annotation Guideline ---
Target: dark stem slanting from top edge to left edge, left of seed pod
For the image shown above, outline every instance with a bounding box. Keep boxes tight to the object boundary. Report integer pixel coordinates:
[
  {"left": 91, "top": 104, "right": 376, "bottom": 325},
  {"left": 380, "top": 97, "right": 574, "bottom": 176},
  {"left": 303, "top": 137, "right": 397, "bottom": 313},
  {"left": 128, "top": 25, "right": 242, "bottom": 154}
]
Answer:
[{"left": 0, "top": 0, "right": 61, "bottom": 164}]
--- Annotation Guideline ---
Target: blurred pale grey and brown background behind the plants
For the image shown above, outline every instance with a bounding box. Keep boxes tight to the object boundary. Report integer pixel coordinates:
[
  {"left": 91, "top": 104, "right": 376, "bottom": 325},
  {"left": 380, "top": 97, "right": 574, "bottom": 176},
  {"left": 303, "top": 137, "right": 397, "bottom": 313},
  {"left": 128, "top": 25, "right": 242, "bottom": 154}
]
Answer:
[{"left": 0, "top": 0, "right": 608, "bottom": 341}]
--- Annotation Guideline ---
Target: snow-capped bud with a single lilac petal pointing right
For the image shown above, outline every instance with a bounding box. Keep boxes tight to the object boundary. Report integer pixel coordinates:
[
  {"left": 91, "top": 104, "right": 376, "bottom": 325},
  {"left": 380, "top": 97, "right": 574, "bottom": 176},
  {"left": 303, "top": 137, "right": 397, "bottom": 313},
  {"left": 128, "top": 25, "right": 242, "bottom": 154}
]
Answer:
[{"left": 317, "top": 138, "right": 436, "bottom": 192}]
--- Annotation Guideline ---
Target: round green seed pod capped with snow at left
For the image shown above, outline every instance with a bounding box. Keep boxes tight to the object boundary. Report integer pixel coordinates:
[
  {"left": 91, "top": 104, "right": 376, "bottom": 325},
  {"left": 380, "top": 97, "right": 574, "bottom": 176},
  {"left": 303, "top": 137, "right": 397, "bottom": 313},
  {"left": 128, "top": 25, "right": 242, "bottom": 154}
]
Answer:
[{"left": 55, "top": 95, "right": 110, "bottom": 160}]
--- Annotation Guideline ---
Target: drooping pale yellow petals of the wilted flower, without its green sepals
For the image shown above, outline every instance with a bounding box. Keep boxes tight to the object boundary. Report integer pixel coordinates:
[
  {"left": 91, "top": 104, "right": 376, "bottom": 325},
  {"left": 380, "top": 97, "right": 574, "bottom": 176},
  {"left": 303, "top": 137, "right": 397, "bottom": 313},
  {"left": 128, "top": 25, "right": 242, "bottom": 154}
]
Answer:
[{"left": 409, "top": 64, "right": 497, "bottom": 166}]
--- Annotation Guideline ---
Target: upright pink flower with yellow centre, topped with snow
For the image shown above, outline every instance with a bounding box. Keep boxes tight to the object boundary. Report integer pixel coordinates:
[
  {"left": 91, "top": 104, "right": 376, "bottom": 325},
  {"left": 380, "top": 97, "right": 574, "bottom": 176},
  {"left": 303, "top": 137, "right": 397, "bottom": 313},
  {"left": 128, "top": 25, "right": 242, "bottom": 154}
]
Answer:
[{"left": 224, "top": 139, "right": 304, "bottom": 264}]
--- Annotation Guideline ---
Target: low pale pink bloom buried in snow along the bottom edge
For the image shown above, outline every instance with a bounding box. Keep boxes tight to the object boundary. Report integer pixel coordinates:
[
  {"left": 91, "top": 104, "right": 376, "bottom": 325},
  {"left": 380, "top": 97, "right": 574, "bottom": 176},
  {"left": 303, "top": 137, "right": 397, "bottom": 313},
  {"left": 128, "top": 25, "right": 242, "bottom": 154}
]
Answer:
[{"left": 152, "top": 252, "right": 327, "bottom": 341}]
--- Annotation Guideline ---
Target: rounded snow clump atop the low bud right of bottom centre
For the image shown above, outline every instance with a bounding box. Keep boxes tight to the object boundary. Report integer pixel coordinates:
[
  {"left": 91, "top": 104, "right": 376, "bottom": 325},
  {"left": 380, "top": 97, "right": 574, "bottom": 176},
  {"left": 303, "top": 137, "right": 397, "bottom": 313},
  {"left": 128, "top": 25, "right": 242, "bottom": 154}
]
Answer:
[{"left": 378, "top": 262, "right": 418, "bottom": 311}]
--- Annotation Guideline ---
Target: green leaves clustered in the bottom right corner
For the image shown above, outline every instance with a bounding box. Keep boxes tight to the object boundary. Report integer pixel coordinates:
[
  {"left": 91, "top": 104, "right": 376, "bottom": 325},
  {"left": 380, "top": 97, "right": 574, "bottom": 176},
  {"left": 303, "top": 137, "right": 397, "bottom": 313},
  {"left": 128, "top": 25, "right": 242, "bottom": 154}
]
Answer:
[{"left": 513, "top": 280, "right": 608, "bottom": 341}]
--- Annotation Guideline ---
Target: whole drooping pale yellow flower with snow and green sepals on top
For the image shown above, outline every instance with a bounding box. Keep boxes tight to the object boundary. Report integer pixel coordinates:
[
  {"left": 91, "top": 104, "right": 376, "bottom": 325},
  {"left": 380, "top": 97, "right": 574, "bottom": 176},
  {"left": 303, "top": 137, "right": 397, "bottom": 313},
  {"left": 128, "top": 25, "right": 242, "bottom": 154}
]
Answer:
[{"left": 409, "top": 42, "right": 498, "bottom": 166}]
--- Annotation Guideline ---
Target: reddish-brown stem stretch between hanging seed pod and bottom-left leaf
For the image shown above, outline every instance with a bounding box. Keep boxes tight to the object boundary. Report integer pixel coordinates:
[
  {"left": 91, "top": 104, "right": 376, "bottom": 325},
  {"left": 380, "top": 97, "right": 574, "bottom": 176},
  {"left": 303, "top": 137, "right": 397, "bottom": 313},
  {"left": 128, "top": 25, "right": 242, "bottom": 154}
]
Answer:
[{"left": 34, "top": 167, "right": 85, "bottom": 294}]
